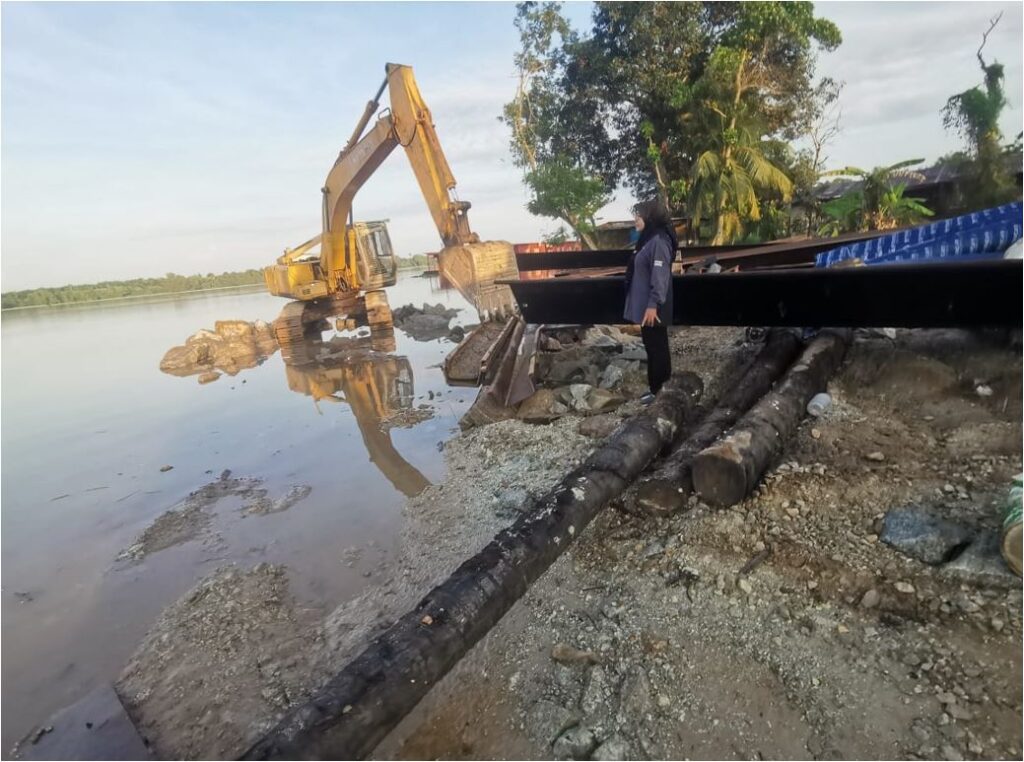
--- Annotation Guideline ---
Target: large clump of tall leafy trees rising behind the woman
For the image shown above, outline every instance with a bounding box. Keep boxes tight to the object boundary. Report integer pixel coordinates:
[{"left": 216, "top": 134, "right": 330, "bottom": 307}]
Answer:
[{"left": 503, "top": 2, "right": 841, "bottom": 240}]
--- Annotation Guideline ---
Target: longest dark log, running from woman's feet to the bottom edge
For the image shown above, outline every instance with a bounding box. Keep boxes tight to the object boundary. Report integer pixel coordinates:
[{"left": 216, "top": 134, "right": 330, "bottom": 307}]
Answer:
[{"left": 244, "top": 374, "right": 703, "bottom": 759}]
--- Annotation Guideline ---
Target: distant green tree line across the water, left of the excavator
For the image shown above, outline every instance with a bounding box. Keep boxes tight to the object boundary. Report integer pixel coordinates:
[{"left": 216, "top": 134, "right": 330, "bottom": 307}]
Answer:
[{"left": 0, "top": 269, "right": 263, "bottom": 309}]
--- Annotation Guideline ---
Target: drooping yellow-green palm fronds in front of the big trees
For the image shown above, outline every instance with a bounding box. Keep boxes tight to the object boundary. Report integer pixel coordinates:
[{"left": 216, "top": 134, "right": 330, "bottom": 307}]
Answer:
[{"left": 690, "top": 127, "right": 793, "bottom": 246}]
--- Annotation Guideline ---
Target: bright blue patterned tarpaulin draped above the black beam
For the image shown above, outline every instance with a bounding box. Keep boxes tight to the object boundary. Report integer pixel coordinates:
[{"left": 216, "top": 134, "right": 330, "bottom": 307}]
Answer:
[{"left": 814, "top": 202, "right": 1024, "bottom": 267}]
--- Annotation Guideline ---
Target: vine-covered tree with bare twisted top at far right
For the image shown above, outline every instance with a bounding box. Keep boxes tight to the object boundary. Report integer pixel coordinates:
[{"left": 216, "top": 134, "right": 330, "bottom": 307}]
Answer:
[{"left": 942, "top": 12, "right": 1020, "bottom": 208}]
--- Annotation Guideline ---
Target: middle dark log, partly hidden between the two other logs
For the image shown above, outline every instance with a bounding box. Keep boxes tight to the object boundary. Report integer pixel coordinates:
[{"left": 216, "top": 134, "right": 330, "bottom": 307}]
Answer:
[{"left": 635, "top": 329, "right": 801, "bottom": 516}]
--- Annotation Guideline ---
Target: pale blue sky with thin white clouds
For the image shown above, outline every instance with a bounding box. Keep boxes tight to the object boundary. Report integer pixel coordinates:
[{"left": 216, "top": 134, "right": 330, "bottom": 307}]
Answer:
[{"left": 0, "top": 2, "right": 1024, "bottom": 291}]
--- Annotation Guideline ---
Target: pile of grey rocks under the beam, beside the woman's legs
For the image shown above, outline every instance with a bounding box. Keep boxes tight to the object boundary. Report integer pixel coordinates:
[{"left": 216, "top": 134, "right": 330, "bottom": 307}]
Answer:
[{"left": 517, "top": 326, "right": 647, "bottom": 423}]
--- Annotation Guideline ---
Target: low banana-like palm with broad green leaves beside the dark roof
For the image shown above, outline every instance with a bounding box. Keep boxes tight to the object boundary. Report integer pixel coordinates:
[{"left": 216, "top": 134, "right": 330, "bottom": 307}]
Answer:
[{"left": 821, "top": 159, "right": 933, "bottom": 230}]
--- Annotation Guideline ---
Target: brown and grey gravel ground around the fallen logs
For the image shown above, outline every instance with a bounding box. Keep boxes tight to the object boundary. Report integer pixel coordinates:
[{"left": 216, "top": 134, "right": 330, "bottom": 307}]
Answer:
[{"left": 119, "top": 329, "right": 1022, "bottom": 759}]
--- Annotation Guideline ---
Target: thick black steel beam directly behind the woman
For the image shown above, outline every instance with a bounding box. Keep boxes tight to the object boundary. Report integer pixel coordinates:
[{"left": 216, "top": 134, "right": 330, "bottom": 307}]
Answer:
[{"left": 503, "top": 259, "right": 1022, "bottom": 328}]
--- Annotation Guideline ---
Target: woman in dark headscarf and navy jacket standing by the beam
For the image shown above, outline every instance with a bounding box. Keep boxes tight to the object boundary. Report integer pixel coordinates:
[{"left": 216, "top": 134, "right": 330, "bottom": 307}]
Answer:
[{"left": 623, "top": 196, "right": 677, "bottom": 403}]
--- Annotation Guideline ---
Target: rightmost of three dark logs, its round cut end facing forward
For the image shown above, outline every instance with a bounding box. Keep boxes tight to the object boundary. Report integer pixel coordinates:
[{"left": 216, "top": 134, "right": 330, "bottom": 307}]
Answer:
[{"left": 693, "top": 330, "right": 850, "bottom": 506}]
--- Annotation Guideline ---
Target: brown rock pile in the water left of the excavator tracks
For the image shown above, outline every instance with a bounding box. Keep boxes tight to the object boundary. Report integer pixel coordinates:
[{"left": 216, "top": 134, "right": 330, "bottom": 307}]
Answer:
[{"left": 160, "top": 321, "right": 279, "bottom": 384}]
